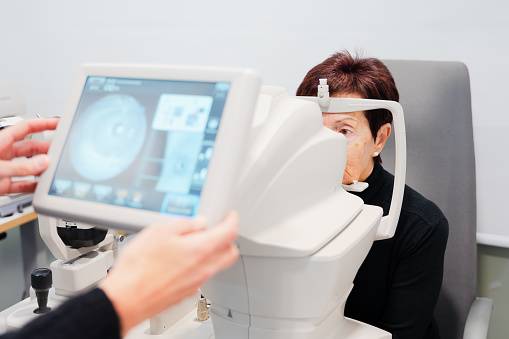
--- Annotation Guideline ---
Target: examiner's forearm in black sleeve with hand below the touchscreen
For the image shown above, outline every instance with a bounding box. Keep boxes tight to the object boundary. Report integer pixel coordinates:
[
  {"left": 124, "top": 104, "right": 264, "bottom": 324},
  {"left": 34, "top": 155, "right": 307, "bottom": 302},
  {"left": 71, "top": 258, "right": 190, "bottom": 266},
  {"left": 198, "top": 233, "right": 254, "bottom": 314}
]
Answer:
[{"left": 0, "top": 212, "right": 238, "bottom": 339}]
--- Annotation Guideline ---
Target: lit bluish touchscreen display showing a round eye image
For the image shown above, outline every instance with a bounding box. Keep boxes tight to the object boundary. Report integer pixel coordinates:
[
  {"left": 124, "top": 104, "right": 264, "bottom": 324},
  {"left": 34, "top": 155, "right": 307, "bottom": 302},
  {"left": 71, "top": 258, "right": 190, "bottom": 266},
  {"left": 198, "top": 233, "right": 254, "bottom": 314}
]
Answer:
[{"left": 49, "top": 77, "right": 230, "bottom": 216}]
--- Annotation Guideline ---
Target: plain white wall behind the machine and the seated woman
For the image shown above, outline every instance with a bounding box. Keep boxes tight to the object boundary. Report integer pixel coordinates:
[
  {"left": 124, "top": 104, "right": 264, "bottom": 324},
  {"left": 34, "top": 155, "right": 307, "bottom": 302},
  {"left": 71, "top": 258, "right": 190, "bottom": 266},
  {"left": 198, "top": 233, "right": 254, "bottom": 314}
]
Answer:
[{"left": 0, "top": 0, "right": 509, "bottom": 246}]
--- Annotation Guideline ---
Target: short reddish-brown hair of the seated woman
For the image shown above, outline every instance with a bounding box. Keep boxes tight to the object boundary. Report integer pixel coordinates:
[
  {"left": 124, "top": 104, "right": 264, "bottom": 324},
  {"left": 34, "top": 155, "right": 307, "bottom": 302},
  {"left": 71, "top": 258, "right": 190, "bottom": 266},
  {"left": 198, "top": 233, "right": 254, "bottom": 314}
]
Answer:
[{"left": 297, "top": 51, "right": 399, "bottom": 164}]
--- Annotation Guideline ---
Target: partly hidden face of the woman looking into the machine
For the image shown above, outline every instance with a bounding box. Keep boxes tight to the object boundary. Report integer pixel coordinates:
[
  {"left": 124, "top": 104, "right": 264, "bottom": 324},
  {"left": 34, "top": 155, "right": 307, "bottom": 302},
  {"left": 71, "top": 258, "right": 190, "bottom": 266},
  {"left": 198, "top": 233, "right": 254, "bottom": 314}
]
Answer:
[{"left": 322, "top": 94, "right": 391, "bottom": 185}]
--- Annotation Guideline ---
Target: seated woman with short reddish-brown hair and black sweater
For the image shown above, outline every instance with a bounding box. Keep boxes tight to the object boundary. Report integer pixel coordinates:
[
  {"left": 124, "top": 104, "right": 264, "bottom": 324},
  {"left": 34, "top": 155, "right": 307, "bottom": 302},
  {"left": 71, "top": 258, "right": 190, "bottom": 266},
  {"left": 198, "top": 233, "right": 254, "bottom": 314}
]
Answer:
[{"left": 297, "top": 51, "right": 448, "bottom": 339}]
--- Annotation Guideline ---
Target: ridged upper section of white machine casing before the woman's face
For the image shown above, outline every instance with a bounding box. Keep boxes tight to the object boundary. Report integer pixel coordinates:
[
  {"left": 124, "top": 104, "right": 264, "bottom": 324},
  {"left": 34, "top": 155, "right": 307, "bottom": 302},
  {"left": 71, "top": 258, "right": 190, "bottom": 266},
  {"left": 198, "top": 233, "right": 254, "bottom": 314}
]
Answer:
[{"left": 234, "top": 87, "right": 363, "bottom": 257}]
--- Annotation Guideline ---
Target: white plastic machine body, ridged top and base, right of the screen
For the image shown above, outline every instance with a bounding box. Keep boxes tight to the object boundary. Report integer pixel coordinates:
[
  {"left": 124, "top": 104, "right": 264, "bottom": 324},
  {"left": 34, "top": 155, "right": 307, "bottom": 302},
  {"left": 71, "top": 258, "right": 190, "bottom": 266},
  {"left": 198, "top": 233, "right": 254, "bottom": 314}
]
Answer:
[{"left": 198, "top": 87, "right": 404, "bottom": 339}]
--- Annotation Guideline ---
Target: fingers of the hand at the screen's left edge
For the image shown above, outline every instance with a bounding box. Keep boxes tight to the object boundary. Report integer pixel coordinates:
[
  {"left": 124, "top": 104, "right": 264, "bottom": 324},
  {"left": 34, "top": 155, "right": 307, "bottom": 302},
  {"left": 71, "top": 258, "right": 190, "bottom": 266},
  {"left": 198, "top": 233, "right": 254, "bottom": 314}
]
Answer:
[{"left": 0, "top": 118, "right": 58, "bottom": 195}]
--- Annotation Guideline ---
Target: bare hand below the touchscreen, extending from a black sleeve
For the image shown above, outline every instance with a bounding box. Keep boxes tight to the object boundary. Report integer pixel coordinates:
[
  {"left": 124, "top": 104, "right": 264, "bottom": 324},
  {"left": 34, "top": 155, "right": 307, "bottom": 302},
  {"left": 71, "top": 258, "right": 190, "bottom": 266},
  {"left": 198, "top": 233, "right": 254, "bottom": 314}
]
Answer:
[{"left": 101, "top": 212, "right": 239, "bottom": 336}]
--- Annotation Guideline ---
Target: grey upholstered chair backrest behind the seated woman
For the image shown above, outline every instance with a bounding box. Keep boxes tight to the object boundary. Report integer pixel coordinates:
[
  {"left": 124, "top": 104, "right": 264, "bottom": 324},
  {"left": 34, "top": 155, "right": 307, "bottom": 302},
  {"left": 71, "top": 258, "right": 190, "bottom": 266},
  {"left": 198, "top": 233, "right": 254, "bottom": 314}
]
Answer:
[{"left": 382, "top": 60, "right": 477, "bottom": 339}]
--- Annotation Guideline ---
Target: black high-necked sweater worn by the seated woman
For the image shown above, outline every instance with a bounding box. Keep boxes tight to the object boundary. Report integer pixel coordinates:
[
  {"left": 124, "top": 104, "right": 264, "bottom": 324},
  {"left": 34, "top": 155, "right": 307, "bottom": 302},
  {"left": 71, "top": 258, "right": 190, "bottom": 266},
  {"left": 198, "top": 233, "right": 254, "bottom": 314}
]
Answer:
[{"left": 345, "top": 166, "right": 449, "bottom": 339}]
